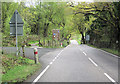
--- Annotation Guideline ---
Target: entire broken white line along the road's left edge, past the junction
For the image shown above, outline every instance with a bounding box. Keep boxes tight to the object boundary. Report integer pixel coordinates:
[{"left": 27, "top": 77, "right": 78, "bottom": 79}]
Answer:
[{"left": 32, "top": 46, "right": 68, "bottom": 84}]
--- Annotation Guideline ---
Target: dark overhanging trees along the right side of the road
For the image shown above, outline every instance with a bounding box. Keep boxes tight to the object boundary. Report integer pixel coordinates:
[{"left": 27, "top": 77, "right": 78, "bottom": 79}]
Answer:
[{"left": 70, "top": 2, "right": 120, "bottom": 49}]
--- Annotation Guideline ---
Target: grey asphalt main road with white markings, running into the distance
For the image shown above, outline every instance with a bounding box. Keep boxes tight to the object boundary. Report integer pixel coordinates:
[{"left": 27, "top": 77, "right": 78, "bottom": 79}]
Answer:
[{"left": 27, "top": 41, "right": 119, "bottom": 84}]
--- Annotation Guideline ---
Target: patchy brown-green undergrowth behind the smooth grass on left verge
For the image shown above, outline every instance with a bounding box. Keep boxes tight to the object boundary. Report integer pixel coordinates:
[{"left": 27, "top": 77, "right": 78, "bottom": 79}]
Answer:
[{"left": 2, "top": 54, "right": 33, "bottom": 73}]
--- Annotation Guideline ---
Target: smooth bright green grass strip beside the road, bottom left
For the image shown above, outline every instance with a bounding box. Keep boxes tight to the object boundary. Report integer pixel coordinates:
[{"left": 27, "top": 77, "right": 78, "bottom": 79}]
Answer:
[{"left": 2, "top": 64, "right": 38, "bottom": 82}]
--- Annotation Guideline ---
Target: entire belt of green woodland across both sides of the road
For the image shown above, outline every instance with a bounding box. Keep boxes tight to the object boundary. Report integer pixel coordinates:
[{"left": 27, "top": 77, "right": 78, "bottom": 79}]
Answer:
[{"left": 1, "top": 1, "right": 120, "bottom": 55}]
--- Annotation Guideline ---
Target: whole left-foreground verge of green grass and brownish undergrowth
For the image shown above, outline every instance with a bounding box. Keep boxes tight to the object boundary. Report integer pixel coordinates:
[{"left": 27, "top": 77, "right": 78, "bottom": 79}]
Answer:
[{"left": 2, "top": 54, "right": 41, "bottom": 83}]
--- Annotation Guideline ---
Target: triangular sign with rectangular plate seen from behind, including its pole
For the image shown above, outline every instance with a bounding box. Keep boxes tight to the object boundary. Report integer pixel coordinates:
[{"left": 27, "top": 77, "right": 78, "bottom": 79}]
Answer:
[{"left": 9, "top": 10, "right": 24, "bottom": 56}]
